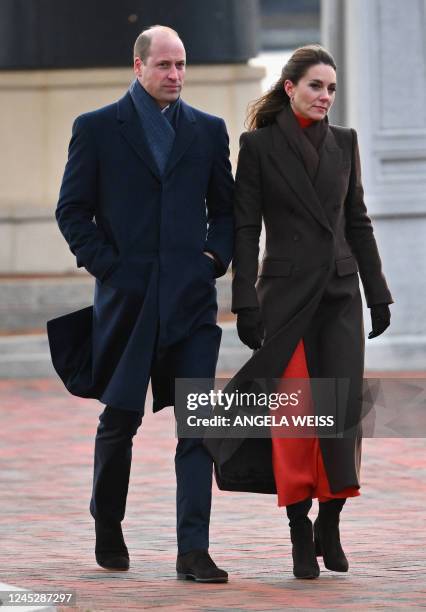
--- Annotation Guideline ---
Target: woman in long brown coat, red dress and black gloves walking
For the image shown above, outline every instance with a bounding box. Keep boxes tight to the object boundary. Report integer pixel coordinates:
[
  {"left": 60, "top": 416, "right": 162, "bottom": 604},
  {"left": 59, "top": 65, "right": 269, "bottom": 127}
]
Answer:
[{"left": 206, "top": 45, "right": 393, "bottom": 578}]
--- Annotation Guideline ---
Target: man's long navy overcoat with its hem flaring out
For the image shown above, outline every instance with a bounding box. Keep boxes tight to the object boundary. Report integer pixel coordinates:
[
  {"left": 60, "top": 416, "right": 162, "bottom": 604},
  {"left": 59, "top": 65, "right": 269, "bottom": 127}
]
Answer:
[{"left": 48, "top": 93, "right": 233, "bottom": 411}]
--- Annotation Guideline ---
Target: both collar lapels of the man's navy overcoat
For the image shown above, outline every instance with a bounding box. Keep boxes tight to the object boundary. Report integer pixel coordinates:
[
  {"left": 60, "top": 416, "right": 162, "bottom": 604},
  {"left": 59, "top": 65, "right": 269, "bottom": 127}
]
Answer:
[{"left": 117, "top": 92, "right": 196, "bottom": 181}]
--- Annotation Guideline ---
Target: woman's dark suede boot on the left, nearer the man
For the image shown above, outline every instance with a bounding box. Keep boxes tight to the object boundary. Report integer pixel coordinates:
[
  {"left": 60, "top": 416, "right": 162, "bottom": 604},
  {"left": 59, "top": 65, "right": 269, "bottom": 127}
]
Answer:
[{"left": 286, "top": 498, "right": 320, "bottom": 578}]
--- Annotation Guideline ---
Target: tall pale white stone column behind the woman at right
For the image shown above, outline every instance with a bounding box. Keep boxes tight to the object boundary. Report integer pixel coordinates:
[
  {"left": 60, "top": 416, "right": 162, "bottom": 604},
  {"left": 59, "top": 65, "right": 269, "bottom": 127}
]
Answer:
[{"left": 323, "top": 0, "right": 426, "bottom": 370}]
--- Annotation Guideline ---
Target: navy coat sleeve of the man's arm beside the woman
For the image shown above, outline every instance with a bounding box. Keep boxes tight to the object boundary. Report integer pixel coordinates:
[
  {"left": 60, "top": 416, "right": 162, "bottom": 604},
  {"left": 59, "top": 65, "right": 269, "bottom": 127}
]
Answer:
[{"left": 205, "top": 119, "right": 234, "bottom": 276}]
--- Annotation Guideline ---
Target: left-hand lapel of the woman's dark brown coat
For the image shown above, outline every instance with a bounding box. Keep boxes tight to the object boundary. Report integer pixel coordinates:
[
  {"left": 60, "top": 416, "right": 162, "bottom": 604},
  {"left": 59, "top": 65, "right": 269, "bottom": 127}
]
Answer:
[{"left": 269, "top": 123, "right": 330, "bottom": 229}]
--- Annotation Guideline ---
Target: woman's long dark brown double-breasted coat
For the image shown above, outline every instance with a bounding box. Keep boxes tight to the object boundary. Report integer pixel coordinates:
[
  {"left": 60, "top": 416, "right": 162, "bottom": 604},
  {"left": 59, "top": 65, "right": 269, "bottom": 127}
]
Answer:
[{"left": 206, "top": 110, "right": 392, "bottom": 493}]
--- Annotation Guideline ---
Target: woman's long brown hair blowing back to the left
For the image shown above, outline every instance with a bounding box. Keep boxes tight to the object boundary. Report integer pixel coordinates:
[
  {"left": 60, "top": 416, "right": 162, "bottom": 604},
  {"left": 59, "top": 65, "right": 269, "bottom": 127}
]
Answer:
[{"left": 246, "top": 45, "right": 337, "bottom": 130}]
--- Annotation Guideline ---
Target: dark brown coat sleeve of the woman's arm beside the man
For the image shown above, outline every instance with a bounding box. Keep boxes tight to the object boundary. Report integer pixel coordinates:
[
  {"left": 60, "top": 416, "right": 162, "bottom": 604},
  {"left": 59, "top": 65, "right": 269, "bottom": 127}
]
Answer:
[{"left": 232, "top": 132, "right": 262, "bottom": 312}]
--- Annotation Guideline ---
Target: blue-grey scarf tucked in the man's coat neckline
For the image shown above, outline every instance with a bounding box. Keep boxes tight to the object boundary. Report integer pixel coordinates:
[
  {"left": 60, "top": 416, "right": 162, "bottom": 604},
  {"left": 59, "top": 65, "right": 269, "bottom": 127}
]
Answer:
[{"left": 129, "top": 79, "right": 180, "bottom": 175}]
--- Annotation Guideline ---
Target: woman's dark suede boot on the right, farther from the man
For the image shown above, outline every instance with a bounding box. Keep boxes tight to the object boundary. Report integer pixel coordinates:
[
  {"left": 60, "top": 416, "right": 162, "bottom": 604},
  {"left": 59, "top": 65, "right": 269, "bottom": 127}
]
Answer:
[{"left": 314, "top": 498, "right": 349, "bottom": 572}]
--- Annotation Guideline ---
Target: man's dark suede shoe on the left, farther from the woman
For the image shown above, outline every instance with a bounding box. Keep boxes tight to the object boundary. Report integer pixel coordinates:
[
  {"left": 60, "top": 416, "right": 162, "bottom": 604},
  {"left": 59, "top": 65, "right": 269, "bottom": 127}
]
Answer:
[{"left": 95, "top": 521, "right": 130, "bottom": 572}]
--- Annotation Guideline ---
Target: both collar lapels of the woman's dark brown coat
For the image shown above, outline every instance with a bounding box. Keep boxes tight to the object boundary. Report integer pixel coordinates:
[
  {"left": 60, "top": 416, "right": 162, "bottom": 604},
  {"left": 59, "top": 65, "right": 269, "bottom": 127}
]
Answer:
[{"left": 270, "top": 106, "right": 342, "bottom": 230}]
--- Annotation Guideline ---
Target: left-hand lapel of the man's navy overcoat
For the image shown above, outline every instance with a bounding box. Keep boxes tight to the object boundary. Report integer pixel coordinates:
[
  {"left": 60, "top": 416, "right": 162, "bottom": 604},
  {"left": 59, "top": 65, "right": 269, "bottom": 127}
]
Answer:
[{"left": 117, "top": 93, "right": 161, "bottom": 180}]
